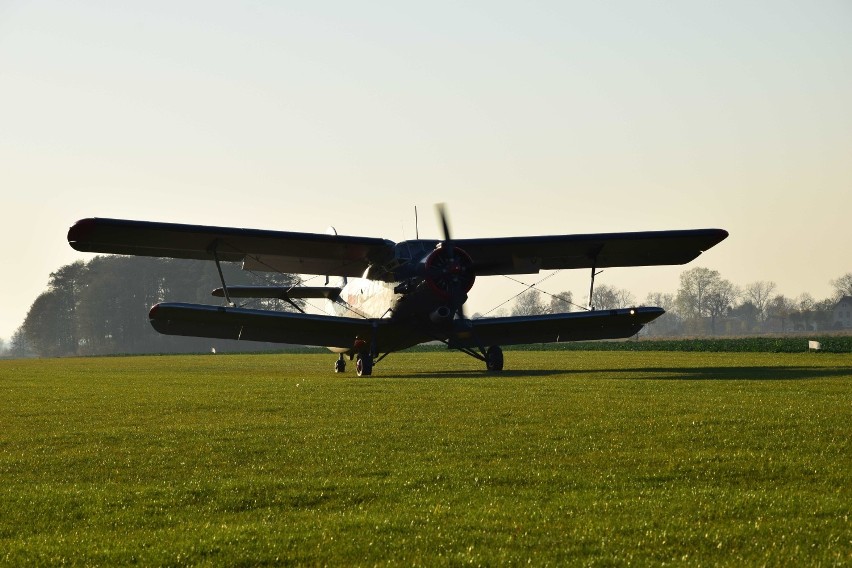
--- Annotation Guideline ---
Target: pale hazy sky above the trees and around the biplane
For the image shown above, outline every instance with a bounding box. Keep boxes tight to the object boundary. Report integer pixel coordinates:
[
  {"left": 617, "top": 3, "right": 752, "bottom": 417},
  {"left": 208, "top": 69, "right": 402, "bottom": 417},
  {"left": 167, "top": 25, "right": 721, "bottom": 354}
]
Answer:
[{"left": 0, "top": 0, "right": 852, "bottom": 339}]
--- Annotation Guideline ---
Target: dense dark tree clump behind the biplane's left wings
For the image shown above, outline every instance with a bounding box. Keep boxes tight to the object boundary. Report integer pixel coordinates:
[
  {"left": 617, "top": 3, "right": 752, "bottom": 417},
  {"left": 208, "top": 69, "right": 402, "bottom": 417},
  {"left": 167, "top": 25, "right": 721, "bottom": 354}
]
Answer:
[{"left": 7, "top": 256, "right": 297, "bottom": 357}]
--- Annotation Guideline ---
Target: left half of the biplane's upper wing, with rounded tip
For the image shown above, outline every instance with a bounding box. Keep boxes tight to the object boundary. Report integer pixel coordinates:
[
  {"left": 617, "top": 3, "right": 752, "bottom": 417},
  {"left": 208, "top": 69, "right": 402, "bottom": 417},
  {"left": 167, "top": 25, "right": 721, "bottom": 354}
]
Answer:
[{"left": 68, "top": 218, "right": 394, "bottom": 276}]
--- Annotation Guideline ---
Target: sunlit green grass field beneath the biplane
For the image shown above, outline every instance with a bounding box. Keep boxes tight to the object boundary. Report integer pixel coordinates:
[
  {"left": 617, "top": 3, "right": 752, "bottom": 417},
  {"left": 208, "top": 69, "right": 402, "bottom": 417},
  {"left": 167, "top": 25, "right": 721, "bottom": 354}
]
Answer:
[{"left": 0, "top": 351, "right": 852, "bottom": 566}]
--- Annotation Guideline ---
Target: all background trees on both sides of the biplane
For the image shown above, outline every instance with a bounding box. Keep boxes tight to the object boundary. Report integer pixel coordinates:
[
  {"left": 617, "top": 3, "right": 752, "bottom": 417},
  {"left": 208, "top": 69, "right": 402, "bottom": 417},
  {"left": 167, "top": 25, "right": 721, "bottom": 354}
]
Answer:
[{"left": 0, "top": 256, "right": 852, "bottom": 357}]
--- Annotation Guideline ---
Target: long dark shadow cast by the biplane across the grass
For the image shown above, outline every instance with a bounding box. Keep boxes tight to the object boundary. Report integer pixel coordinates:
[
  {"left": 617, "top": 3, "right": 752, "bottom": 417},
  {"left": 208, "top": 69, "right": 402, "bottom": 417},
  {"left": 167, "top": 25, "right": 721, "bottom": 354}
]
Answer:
[{"left": 377, "top": 366, "right": 852, "bottom": 381}]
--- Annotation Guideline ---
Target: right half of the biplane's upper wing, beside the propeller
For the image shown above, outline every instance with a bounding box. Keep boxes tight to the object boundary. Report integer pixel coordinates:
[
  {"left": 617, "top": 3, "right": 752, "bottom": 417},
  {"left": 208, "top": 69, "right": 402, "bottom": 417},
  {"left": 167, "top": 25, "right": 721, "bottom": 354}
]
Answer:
[{"left": 453, "top": 229, "right": 728, "bottom": 276}]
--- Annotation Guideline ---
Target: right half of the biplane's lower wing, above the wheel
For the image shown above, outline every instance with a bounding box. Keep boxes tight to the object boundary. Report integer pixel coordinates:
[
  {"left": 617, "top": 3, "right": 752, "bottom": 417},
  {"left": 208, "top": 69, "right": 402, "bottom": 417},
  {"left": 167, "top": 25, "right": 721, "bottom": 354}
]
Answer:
[{"left": 454, "top": 308, "right": 665, "bottom": 347}]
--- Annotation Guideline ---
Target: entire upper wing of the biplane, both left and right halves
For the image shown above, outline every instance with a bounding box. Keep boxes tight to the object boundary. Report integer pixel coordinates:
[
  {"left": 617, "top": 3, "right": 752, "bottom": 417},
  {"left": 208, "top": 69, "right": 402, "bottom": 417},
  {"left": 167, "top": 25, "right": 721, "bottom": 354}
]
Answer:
[{"left": 68, "top": 218, "right": 728, "bottom": 276}]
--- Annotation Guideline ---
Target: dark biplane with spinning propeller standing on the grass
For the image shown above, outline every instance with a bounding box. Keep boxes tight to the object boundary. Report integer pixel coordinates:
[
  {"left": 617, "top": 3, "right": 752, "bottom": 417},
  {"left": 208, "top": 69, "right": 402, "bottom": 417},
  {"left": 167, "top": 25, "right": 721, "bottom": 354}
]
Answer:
[{"left": 68, "top": 206, "right": 728, "bottom": 376}]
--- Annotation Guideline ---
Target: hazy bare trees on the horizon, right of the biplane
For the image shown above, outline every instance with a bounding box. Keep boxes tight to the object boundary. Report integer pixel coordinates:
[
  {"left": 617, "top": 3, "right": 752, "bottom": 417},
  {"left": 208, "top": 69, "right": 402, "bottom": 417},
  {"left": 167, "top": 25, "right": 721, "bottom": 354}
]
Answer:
[{"left": 511, "top": 267, "right": 852, "bottom": 336}]
